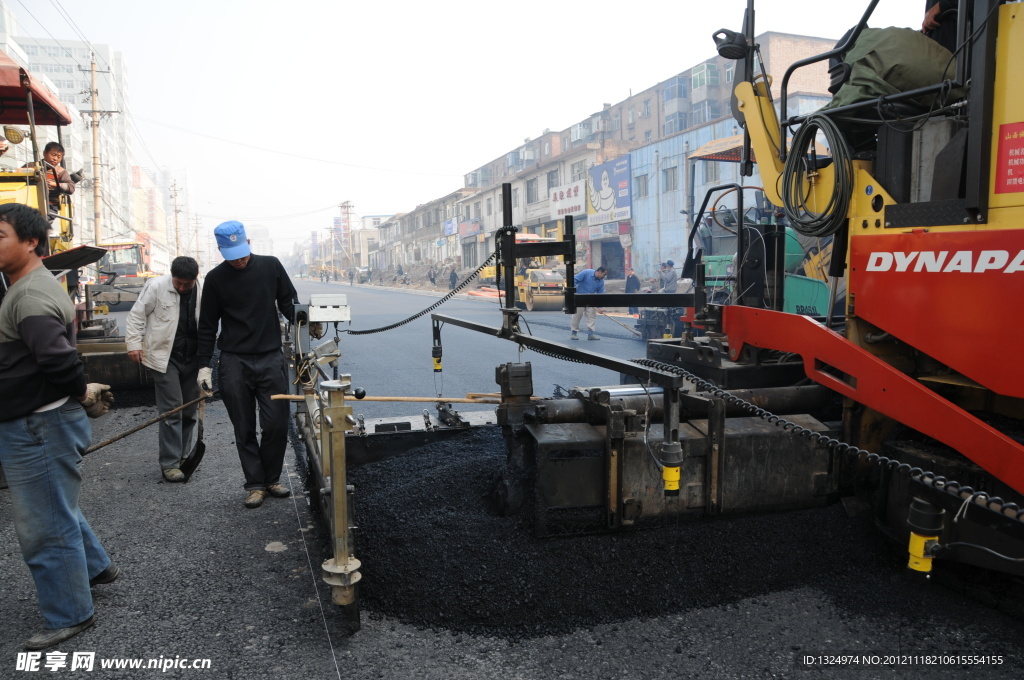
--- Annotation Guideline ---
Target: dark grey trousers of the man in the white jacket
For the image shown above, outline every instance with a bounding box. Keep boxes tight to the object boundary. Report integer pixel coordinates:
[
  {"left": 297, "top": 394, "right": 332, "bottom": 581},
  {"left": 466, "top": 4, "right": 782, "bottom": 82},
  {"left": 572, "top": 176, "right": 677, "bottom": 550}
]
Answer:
[{"left": 151, "top": 355, "right": 199, "bottom": 470}]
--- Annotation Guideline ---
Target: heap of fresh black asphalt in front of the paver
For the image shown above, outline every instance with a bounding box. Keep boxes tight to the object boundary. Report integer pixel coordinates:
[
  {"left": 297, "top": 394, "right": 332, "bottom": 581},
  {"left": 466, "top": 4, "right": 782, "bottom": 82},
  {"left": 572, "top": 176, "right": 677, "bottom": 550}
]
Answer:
[{"left": 349, "top": 430, "right": 905, "bottom": 639}]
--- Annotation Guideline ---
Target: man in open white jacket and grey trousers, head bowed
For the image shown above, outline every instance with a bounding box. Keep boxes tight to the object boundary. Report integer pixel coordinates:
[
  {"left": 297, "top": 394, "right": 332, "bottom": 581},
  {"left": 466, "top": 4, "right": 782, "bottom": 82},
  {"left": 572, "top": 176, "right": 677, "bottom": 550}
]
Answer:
[{"left": 126, "top": 257, "right": 201, "bottom": 482}]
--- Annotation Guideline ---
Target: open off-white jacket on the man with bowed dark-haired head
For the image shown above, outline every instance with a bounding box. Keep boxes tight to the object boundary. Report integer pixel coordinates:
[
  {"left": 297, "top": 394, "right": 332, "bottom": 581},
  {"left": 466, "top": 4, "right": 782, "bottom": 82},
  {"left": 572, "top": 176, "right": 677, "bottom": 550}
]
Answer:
[{"left": 125, "top": 274, "right": 203, "bottom": 373}]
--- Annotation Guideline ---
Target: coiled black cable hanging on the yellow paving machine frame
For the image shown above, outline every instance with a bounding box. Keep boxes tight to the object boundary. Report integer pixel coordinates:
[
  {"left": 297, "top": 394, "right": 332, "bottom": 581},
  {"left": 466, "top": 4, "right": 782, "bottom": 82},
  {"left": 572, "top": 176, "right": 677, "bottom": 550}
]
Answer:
[{"left": 782, "top": 114, "right": 854, "bottom": 237}]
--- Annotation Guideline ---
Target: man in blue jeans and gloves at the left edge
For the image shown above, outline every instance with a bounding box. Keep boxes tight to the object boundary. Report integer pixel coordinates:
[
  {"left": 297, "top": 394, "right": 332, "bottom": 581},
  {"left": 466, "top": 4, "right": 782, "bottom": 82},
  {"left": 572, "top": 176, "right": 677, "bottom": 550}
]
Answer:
[{"left": 0, "top": 203, "right": 120, "bottom": 649}]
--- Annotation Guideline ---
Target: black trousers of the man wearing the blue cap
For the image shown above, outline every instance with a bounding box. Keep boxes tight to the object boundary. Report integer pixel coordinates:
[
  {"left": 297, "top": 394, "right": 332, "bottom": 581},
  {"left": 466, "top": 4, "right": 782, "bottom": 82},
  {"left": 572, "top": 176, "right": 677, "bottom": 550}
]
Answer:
[{"left": 218, "top": 349, "right": 291, "bottom": 491}]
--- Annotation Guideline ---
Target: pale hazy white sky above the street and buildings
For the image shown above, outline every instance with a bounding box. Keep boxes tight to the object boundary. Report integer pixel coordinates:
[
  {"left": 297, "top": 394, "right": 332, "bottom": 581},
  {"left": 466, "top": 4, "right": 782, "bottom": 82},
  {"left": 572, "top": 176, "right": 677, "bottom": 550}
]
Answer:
[{"left": 6, "top": 0, "right": 925, "bottom": 251}]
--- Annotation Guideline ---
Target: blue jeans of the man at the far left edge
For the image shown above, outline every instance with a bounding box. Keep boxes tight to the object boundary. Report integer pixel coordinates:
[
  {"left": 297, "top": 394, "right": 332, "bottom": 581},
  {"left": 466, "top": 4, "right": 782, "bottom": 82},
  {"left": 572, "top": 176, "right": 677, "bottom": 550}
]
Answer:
[{"left": 0, "top": 398, "right": 111, "bottom": 629}]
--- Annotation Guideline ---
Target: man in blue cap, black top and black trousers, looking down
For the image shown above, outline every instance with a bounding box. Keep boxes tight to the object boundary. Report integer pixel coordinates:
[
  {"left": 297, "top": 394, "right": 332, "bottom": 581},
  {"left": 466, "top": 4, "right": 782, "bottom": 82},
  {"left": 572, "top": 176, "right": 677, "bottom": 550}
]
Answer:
[{"left": 197, "top": 220, "right": 296, "bottom": 508}]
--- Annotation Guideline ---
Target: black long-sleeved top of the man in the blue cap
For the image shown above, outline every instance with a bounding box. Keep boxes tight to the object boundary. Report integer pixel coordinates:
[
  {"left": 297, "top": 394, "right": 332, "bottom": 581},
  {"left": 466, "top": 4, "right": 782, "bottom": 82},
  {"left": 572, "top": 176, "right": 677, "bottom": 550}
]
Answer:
[{"left": 196, "top": 255, "right": 296, "bottom": 367}]
